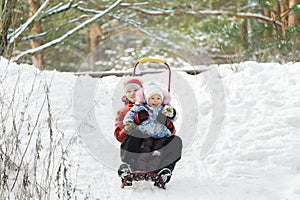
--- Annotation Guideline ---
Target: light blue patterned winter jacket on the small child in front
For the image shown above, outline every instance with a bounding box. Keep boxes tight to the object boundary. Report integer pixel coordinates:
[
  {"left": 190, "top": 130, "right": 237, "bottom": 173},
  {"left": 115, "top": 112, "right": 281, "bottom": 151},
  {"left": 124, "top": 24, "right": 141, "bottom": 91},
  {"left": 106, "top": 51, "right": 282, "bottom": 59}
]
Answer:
[{"left": 123, "top": 104, "right": 172, "bottom": 138}]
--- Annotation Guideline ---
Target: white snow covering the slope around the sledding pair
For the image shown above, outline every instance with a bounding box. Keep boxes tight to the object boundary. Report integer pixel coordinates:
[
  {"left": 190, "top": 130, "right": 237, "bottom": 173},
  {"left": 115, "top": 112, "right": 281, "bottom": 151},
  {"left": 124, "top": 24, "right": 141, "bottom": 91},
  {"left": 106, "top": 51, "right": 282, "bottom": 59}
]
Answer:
[{"left": 0, "top": 57, "right": 300, "bottom": 200}]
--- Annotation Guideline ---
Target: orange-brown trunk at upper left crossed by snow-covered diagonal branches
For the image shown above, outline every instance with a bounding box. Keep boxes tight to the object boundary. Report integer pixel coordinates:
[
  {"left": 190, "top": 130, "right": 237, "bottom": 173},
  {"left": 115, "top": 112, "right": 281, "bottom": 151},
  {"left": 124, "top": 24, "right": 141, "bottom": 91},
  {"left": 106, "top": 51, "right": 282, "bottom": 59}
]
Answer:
[{"left": 29, "top": 0, "right": 45, "bottom": 70}]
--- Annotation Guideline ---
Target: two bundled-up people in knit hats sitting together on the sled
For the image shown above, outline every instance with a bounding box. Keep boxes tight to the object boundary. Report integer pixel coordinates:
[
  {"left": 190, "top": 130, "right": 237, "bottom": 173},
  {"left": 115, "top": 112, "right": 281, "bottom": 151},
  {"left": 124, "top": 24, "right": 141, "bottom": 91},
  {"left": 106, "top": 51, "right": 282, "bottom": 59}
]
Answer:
[{"left": 114, "top": 79, "right": 182, "bottom": 187}]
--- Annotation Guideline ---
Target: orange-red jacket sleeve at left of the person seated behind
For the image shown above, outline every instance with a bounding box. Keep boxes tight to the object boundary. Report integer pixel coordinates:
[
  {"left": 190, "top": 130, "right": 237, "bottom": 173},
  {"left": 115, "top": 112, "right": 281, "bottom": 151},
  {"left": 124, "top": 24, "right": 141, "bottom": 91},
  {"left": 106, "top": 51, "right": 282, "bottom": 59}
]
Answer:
[{"left": 114, "top": 97, "right": 134, "bottom": 142}]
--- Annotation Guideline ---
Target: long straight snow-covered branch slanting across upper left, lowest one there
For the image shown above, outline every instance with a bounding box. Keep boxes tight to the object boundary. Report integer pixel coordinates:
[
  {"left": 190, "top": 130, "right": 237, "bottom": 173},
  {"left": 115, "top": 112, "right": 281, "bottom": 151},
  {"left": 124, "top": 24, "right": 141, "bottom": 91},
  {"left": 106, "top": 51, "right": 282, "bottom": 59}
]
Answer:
[{"left": 14, "top": 0, "right": 122, "bottom": 60}]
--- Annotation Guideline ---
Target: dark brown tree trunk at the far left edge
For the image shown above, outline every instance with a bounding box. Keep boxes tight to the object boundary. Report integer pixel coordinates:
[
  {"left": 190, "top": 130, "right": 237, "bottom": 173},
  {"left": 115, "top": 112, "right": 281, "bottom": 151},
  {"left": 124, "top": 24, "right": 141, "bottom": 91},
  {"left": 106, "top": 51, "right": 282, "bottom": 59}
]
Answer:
[{"left": 0, "top": 0, "right": 17, "bottom": 58}]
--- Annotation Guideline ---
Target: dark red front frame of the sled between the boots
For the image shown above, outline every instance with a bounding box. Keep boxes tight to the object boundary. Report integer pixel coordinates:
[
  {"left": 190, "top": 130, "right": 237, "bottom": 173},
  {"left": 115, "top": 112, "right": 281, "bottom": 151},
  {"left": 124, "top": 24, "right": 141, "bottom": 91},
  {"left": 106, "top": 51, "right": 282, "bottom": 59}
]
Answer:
[{"left": 121, "top": 172, "right": 166, "bottom": 189}]
